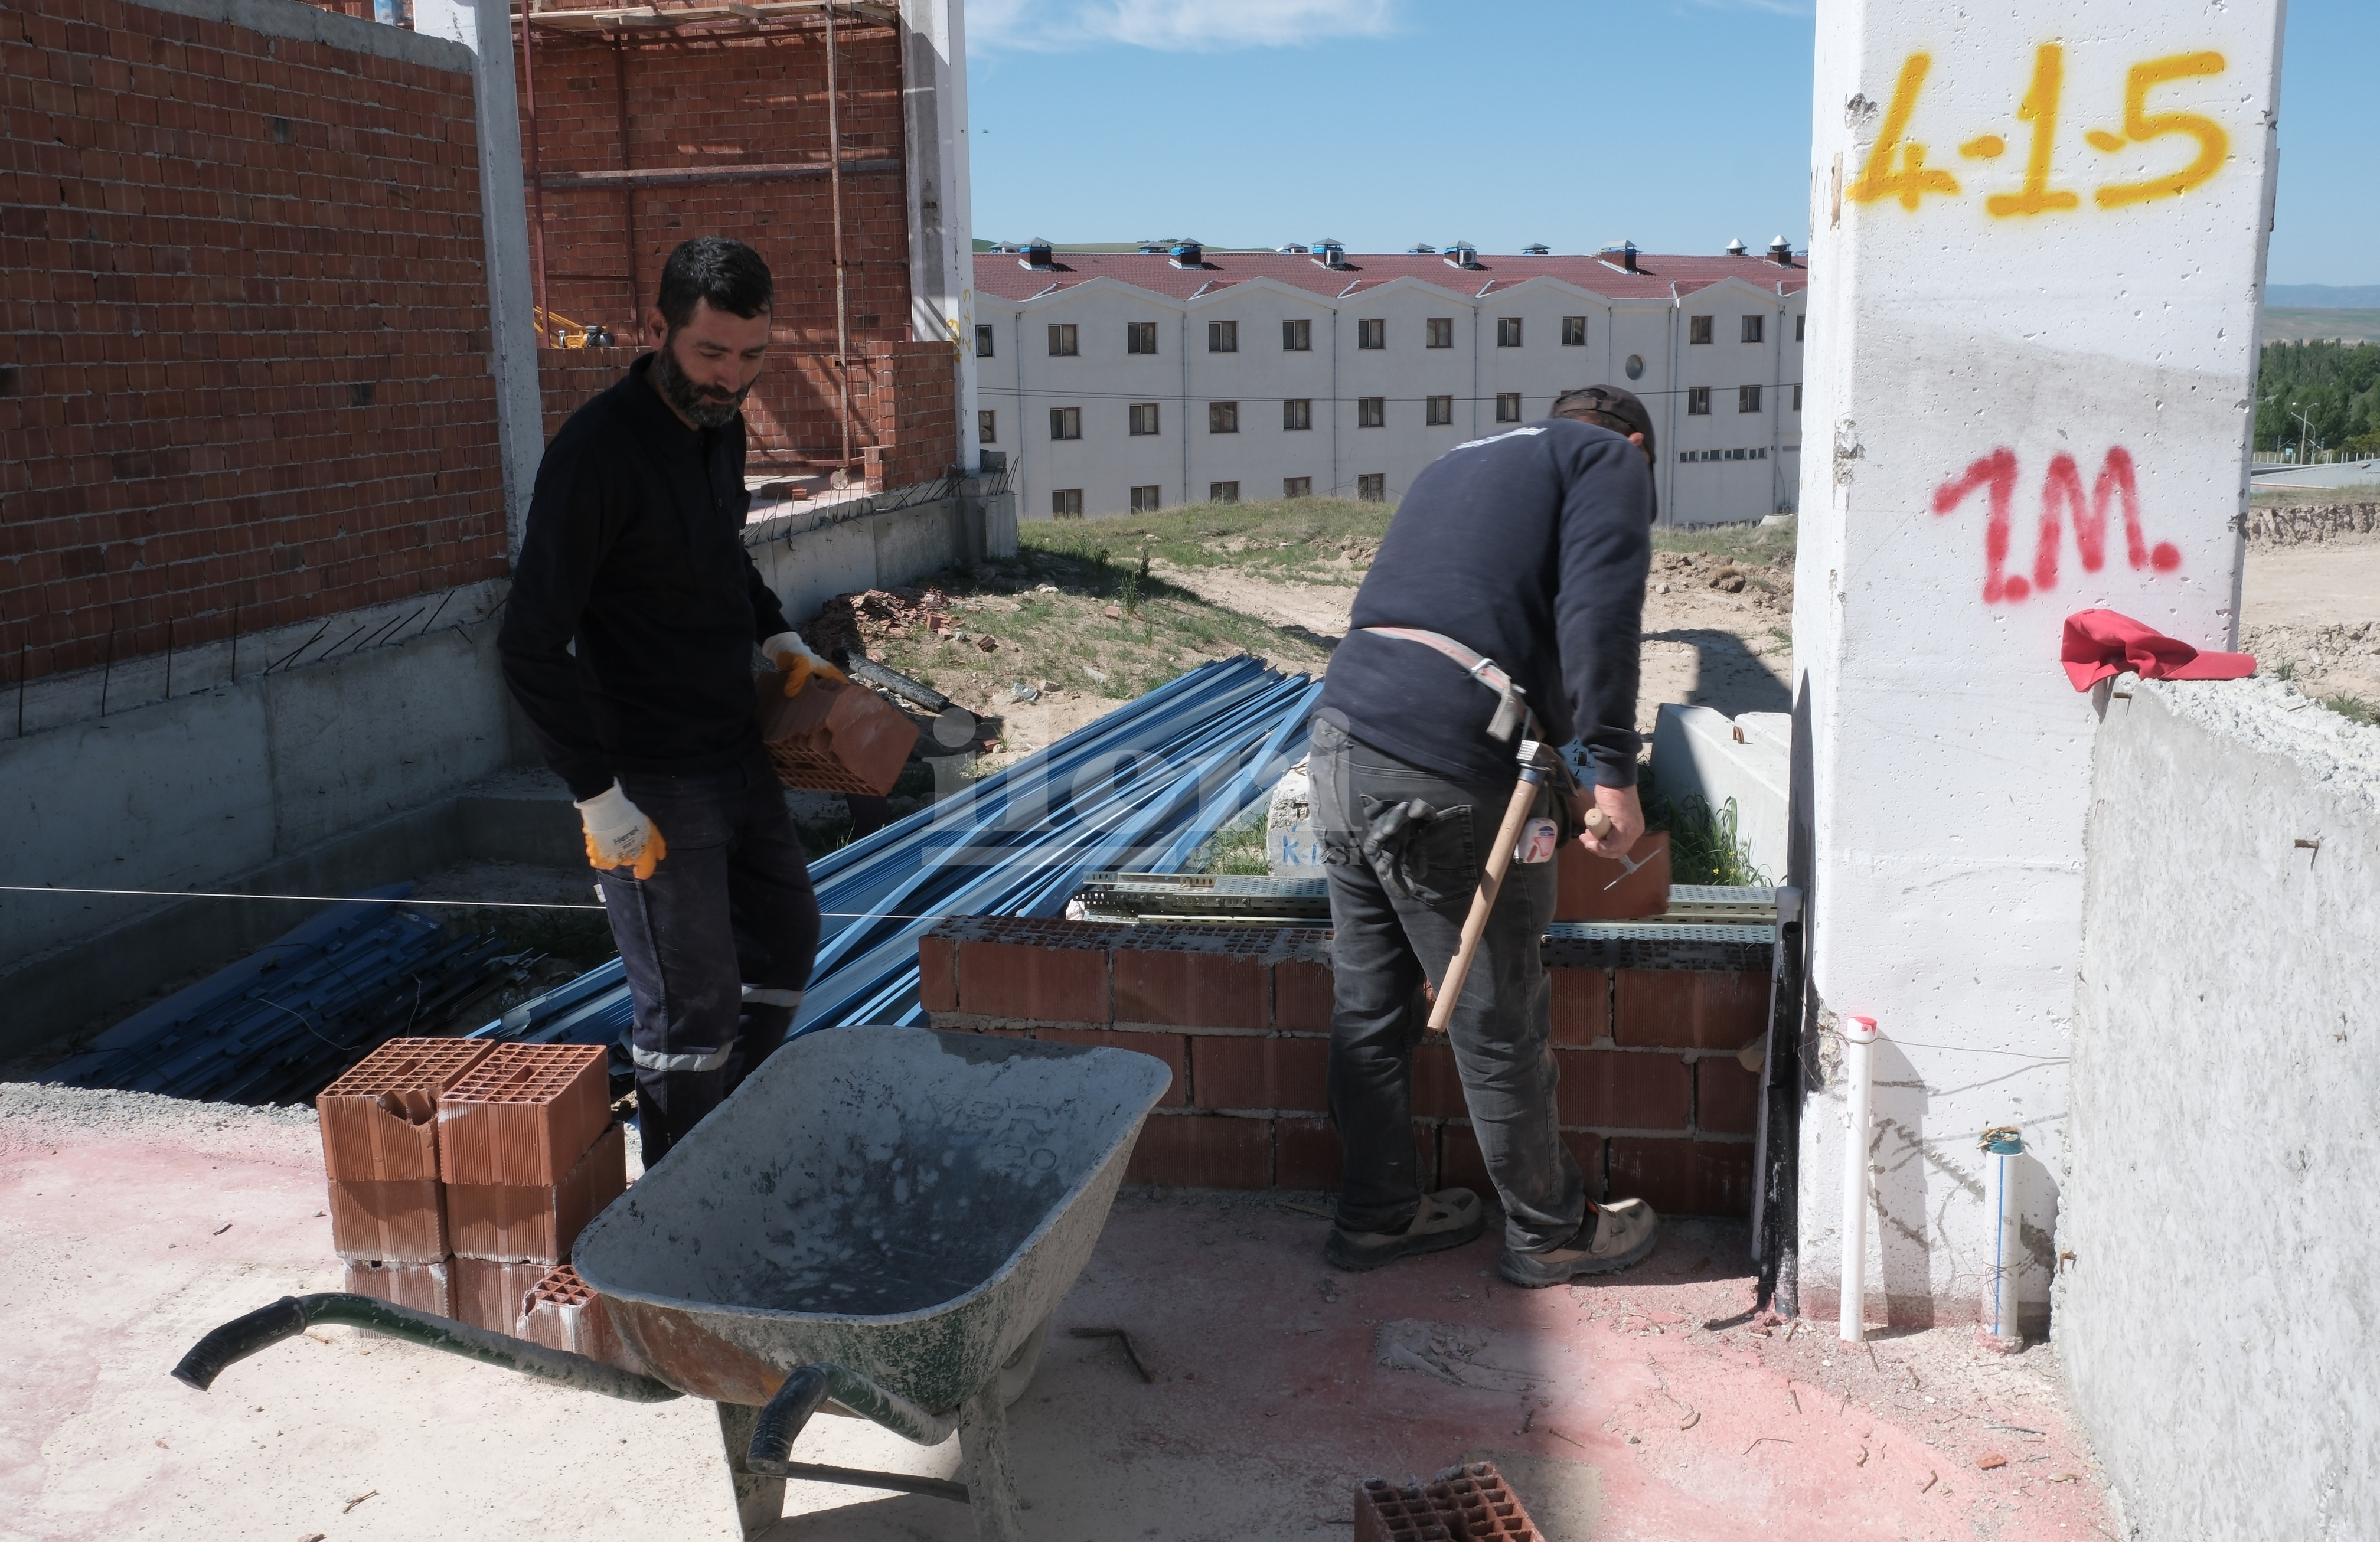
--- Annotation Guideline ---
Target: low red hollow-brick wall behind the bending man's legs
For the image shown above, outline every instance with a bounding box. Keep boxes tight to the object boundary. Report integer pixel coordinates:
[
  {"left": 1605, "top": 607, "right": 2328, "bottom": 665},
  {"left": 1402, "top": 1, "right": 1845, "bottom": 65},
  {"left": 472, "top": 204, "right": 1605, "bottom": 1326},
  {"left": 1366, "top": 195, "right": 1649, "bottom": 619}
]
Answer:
[{"left": 919, "top": 916, "right": 1771, "bottom": 1218}]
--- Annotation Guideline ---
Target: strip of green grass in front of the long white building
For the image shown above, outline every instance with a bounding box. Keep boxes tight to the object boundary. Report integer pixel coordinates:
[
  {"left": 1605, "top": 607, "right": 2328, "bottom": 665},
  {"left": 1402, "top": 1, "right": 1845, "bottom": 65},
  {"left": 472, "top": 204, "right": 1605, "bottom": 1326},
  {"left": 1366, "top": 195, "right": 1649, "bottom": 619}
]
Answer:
[{"left": 1018, "top": 497, "right": 1397, "bottom": 586}]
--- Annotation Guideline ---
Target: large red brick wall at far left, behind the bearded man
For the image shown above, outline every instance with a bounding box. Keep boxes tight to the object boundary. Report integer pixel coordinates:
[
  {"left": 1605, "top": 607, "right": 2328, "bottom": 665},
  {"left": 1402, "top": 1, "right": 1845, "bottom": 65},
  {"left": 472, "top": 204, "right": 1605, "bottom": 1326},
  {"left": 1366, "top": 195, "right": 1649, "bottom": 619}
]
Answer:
[{"left": 0, "top": 0, "right": 505, "bottom": 676}]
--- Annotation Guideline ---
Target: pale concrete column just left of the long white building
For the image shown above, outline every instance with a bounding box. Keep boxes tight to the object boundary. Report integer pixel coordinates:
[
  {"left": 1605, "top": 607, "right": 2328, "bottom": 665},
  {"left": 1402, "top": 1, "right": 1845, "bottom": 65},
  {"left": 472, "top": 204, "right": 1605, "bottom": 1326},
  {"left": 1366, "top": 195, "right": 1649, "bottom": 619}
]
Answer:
[{"left": 900, "top": 0, "right": 983, "bottom": 469}]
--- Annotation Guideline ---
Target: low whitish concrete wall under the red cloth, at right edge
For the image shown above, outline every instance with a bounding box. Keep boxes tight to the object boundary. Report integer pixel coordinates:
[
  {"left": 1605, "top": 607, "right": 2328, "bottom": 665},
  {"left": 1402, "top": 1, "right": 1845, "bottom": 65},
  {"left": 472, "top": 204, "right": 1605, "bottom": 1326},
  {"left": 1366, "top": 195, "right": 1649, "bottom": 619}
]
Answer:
[{"left": 2056, "top": 681, "right": 2380, "bottom": 1542}]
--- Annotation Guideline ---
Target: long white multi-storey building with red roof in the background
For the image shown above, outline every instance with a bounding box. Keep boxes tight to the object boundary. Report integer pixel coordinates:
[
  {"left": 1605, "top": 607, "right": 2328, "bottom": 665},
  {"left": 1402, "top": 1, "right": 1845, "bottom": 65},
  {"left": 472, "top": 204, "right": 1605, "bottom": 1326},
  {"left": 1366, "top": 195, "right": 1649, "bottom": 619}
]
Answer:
[{"left": 976, "top": 240, "right": 1809, "bottom": 524}]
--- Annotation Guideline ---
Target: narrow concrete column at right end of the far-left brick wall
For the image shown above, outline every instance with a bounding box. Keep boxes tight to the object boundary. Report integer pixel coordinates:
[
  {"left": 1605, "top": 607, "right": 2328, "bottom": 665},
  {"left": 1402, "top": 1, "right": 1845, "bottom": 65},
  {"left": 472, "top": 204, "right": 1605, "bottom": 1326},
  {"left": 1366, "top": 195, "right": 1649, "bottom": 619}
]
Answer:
[{"left": 414, "top": 0, "right": 545, "bottom": 552}]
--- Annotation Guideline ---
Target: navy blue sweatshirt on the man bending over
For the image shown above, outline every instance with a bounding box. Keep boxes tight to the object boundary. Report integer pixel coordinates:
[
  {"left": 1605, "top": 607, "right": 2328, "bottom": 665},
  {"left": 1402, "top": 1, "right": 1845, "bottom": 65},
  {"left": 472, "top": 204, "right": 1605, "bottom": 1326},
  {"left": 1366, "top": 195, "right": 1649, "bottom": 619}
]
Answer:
[{"left": 1316, "top": 419, "right": 1652, "bottom": 790}]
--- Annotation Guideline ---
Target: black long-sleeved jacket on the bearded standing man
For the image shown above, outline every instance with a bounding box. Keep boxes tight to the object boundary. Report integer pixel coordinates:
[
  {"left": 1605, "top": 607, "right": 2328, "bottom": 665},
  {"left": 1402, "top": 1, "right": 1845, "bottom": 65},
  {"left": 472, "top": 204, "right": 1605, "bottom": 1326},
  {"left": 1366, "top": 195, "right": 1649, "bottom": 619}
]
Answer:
[{"left": 495, "top": 355, "right": 788, "bottom": 799}]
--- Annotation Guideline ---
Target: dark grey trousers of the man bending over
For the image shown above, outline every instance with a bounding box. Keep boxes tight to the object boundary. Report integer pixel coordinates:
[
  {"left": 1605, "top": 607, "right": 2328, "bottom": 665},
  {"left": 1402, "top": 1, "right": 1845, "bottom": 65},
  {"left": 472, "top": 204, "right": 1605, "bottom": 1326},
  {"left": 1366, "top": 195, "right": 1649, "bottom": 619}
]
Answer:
[{"left": 1309, "top": 721, "right": 1588, "bottom": 1252}]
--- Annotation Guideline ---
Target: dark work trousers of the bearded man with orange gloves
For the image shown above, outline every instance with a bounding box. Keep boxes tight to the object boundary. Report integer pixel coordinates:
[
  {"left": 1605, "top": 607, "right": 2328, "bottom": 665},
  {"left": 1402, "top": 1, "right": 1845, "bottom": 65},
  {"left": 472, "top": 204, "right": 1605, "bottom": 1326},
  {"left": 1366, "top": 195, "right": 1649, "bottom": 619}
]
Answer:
[{"left": 600, "top": 750, "right": 819, "bottom": 1166}]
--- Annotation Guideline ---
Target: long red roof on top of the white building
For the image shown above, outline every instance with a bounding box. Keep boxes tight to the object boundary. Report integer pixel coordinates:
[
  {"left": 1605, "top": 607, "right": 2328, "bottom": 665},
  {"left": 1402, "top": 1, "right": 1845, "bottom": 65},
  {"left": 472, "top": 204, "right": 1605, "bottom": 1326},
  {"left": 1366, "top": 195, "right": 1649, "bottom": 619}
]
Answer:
[{"left": 976, "top": 252, "right": 1809, "bottom": 300}]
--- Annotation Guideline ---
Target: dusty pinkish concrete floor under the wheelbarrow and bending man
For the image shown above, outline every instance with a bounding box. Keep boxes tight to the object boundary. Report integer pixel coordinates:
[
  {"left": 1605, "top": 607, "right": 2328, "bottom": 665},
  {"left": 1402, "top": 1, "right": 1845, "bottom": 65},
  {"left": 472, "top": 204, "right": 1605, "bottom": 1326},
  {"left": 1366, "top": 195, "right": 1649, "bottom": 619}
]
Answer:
[{"left": 0, "top": 1087, "right": 2121, "bottom": 1542}]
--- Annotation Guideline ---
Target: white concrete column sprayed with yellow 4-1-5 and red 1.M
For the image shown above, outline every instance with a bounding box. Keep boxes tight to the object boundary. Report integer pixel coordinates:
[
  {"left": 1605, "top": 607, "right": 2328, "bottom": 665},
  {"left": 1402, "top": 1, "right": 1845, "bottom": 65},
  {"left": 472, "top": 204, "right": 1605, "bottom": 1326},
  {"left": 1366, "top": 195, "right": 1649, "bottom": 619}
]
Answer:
[{"left": 1792, "top": 0, "right": 2283, "bottom": 1321}]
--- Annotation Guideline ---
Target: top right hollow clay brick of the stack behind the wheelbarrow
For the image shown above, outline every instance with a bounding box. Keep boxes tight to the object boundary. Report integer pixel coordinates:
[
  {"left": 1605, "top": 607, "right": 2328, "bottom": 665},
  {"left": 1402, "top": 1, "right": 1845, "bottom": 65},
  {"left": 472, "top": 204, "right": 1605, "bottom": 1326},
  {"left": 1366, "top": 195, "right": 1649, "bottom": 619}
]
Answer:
[{"left": 438, "top": 1045, "right": 612, "bottom": 1185}]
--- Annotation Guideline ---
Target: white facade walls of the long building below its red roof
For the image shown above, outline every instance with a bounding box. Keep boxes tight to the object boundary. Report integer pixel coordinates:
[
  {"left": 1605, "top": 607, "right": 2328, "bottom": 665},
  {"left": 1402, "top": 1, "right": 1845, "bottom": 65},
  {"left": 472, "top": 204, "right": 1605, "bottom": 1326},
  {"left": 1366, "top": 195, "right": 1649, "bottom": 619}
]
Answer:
[{"left": 976, "top": 265, "right": 1804, "bottom": 524}]
